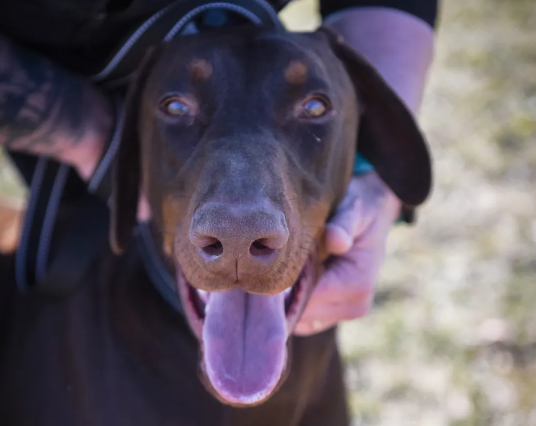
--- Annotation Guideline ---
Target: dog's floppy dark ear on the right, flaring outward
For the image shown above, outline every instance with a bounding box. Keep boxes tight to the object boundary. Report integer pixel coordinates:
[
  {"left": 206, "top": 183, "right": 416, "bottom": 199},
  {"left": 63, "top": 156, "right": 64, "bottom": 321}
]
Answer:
[{"left": 319, "top": 27, "right": 432, "bottom": 210}]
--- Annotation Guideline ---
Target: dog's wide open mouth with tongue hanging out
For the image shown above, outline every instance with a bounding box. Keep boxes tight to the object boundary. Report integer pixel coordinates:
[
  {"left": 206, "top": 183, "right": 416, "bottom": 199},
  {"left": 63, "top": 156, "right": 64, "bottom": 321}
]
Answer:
[{"left": 177, "top": 257, "right": 314, "bottom": 406}]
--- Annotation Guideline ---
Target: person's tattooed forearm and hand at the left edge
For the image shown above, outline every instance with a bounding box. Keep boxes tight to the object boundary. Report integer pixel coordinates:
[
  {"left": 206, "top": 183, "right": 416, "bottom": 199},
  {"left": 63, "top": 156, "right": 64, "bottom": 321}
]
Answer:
[{"left": 0, "top": 36, "right": 113, "bottom": 179}]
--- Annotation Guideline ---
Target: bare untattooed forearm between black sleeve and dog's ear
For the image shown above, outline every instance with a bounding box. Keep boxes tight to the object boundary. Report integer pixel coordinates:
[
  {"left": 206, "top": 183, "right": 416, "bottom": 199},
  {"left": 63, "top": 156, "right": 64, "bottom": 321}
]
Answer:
[{"left": 325, "top": 7, "right": 435, "bottom": 114}]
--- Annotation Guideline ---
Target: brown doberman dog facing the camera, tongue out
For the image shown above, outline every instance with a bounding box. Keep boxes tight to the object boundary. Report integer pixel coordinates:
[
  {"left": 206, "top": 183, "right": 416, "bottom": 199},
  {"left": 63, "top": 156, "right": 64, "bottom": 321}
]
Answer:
[{"left": 0, "top": 28, "right": 431, "bottom": 426}]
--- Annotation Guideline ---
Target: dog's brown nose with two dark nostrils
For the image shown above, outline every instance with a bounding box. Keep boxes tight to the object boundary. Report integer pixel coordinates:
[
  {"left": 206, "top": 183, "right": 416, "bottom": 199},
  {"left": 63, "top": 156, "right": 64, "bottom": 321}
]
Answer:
[{"left": 190, "top": 203, "right": 289, "bottom": 275}]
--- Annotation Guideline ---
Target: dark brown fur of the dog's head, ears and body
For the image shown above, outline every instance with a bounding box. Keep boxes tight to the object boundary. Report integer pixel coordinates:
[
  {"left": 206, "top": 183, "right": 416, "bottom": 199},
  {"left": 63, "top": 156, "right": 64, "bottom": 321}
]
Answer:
[{"left": 0, "top": 29, "right": 431, "bottom": 426}]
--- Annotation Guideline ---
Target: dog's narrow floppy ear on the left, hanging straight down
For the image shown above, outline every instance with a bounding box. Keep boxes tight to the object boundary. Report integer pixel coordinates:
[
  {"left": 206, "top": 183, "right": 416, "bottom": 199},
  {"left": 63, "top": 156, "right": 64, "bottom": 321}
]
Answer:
[{"left": 110, "top": 47, "right": 159, "bottom": 254}]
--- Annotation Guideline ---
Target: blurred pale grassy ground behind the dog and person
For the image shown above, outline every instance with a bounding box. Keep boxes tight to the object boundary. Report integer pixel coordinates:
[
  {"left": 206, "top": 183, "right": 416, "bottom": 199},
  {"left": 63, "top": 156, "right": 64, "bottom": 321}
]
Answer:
[{"left": 0, "top": 0, "right": 536, "bottom": 426}]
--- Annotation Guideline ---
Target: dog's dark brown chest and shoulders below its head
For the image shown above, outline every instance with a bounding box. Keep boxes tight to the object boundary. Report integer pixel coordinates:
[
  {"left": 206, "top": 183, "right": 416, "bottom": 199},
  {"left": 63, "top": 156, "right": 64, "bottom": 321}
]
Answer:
[{"left": 0, "top": 250, "right": 344, "bottom": 426}]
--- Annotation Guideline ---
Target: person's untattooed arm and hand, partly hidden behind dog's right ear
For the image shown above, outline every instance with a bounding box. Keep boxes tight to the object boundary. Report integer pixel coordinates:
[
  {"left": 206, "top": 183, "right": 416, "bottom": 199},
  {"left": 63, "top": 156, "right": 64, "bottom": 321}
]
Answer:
[{"left": 295, "top": 5, "right": 434, "bottom": 335}]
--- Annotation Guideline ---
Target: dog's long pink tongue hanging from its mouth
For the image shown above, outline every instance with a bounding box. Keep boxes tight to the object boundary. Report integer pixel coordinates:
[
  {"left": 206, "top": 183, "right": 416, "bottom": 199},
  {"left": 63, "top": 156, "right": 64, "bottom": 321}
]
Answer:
[{"left": 203, "top": 289, "right": 287, "bottom": 404}]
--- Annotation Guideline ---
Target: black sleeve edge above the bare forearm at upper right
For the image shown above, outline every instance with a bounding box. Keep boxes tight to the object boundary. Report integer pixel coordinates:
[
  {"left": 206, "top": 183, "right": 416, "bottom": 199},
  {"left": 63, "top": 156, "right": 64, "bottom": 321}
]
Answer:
[{"left": 320, "top": 0, "right": 439, "bottom": 28}]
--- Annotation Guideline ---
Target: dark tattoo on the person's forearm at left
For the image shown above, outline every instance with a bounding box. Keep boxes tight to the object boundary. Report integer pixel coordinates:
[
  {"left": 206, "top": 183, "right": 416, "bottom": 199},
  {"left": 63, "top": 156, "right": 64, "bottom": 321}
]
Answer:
[{"left": 0, "top": 37, "right": 109, "bottom": 156}]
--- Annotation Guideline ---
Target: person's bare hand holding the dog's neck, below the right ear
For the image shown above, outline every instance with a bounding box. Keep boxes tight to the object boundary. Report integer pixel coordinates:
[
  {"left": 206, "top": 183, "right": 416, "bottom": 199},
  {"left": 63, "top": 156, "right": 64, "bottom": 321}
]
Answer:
[{"left": 294, "top": 172, "right": 400, "bottom": 336}]
